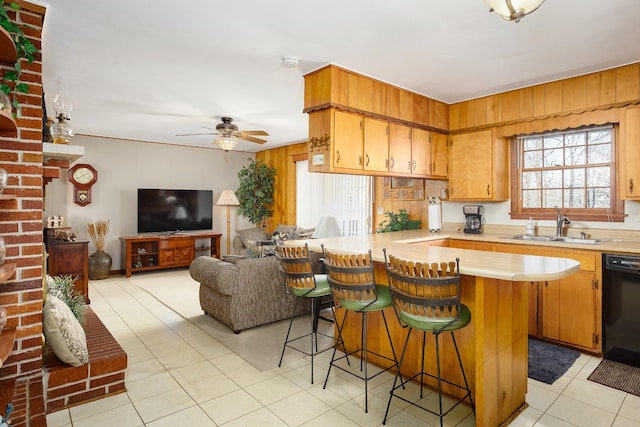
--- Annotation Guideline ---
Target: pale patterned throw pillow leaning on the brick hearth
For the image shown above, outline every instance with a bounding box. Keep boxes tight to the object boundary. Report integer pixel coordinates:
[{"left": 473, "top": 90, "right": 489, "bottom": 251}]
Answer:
[{"left": 42, "top": 295, "right": 89, "bottom": 366}]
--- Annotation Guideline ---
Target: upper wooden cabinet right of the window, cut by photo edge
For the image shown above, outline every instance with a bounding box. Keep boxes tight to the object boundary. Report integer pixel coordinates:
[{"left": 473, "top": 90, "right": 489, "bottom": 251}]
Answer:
[{"left": 620, "top": 107, "right": 640, "bottom": 200}]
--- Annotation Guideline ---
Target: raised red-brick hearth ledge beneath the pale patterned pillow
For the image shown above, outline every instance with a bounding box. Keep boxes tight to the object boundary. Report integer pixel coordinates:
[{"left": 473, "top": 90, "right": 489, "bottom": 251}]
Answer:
[{"left": 43, "top": 307, "right": 127, "bottom": 413}]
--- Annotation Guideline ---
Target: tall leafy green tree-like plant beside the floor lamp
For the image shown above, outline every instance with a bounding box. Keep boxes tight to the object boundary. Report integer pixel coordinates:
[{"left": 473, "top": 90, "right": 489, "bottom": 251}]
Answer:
[{"left": 236, "top": 159, "right": 276, "bottom": 229}]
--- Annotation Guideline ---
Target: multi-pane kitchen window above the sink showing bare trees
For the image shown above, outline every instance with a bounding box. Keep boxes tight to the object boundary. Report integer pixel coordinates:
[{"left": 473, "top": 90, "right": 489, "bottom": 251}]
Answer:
[{"left": 511, "top": 125, "right": 623, "bottom": 221}]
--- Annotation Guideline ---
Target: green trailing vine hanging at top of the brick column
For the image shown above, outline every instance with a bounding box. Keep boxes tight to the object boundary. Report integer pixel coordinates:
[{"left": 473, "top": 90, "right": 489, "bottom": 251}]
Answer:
[{"left": 0, "top": 0, "right": 38, "bottom": 116}]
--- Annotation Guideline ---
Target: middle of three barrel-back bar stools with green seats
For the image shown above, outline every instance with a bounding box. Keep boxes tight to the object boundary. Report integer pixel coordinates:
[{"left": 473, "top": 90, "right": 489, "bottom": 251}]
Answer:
[{"left": 322, "top": 247, "right": 398, "bottom": 412}]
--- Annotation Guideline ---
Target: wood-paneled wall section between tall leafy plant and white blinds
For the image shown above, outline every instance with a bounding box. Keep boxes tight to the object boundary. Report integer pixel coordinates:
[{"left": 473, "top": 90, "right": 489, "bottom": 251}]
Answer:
[{"left": 256, "top": 142, "right": 307, "bottom": 232}]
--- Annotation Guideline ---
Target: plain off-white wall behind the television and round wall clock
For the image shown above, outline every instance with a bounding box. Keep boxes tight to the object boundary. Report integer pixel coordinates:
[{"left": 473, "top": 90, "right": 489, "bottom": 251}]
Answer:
[{"left": 44, "top": 135, "right": 255, "bottom": 270}]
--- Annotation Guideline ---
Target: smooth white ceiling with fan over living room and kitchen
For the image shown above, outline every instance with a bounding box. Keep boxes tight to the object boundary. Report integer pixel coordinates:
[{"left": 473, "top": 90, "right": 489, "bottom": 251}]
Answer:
[{"left": 38, "top": 0, "right": 640, "bottom": 151}]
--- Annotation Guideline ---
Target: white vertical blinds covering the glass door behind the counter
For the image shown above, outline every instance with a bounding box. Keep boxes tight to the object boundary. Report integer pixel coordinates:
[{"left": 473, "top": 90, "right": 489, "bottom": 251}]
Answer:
[{"left": 296, "top": 160, "right": 372, "bottom": 236}]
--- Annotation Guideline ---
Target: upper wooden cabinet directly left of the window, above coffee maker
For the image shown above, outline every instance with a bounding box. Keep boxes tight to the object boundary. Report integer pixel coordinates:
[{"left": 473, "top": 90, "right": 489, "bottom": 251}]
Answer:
[{"left": 449, "top": 130, "right": 509, "bottom": 201}]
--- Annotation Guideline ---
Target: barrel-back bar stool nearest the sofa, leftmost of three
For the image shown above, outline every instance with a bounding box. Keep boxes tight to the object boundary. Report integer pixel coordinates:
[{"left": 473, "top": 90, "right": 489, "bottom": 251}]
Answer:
[{"left": 276, "top": 244, "right": 342, "bottom": 384}]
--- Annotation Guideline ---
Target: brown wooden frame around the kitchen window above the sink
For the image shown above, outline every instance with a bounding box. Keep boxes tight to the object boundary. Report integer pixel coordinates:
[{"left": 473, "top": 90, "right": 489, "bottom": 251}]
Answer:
[{"left": 509, "top": 123, "right": 625, "bottom": 222}]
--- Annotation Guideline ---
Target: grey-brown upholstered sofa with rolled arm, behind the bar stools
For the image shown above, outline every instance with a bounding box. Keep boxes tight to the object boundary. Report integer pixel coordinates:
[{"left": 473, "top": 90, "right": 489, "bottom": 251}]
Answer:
[{"left": 189, "top": 256, "right": 310, "bottom": 333}]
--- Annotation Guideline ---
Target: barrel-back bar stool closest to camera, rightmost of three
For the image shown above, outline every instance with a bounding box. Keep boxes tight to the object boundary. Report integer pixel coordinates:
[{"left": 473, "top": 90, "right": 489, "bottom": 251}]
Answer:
[{"left": 382, "top": 249, "right": 475, "bottom": 426}]
